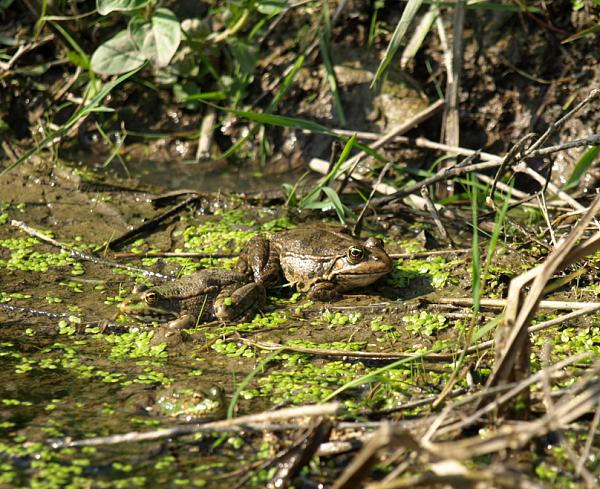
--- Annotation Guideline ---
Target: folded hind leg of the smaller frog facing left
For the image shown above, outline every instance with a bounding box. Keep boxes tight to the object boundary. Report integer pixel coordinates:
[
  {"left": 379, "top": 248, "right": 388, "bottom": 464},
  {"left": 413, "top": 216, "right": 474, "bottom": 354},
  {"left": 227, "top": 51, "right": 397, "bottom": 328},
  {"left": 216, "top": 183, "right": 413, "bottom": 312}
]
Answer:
[{"left": 213, "top": 282, "right": 266, "bottom": 321}]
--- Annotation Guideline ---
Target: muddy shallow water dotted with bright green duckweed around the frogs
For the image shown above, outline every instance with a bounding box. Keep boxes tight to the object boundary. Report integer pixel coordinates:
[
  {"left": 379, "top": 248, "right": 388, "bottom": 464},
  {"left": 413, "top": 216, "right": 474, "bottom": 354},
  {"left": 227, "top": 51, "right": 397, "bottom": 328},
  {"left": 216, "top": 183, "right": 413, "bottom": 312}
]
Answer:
[{"left": 0, "top": 162, "right": 464, "bottom": 487}]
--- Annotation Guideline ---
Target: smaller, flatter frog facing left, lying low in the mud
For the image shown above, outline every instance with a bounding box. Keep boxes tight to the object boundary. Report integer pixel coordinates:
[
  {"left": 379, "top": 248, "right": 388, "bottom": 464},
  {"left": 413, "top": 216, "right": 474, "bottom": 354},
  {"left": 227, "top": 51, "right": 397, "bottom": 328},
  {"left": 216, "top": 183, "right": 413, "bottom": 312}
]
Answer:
[{"left": 119, "top": 269, "right": 265, "bottom": 329}]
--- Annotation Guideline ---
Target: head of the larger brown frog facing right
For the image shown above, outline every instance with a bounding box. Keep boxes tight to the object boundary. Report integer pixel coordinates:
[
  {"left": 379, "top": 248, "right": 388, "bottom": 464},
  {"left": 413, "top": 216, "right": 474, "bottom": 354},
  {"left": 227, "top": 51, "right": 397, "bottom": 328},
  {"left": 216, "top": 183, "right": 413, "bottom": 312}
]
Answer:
[{"left": 328, "top": 238, "right": 392, "bottom": 290}]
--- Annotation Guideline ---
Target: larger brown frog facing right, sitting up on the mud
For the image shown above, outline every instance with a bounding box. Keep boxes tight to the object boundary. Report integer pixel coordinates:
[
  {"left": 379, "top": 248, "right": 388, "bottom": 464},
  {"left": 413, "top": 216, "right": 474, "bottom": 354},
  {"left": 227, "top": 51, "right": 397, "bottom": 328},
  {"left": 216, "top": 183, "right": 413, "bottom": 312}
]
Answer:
[{"left": 238, "top": 226, "right": 392, "bottom": 301}]
